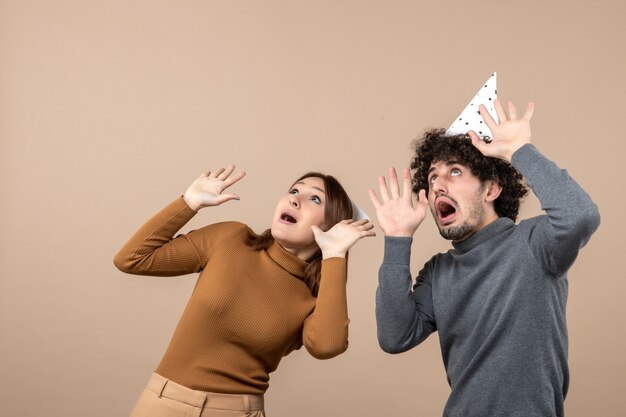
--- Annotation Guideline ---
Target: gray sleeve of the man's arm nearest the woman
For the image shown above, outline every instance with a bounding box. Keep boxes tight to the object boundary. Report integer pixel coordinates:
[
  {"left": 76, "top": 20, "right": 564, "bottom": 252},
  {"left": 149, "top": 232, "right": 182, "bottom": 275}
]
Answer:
[{"left": 376, "top": 237, "right": 436, "bottom": 353}]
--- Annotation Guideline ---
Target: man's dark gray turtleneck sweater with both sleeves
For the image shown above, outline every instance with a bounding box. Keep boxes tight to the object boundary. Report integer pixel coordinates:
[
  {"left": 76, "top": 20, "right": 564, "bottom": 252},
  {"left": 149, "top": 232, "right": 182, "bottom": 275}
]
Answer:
[{"left": 376, "top": 144, "right": 600, "bottom": 417}]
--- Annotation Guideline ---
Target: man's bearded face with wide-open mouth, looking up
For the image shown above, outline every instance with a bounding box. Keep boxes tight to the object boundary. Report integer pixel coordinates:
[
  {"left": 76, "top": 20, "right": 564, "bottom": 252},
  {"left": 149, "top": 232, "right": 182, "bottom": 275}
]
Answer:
[{"left": 428, "top": 160, "right": 493, "bottom": 242}]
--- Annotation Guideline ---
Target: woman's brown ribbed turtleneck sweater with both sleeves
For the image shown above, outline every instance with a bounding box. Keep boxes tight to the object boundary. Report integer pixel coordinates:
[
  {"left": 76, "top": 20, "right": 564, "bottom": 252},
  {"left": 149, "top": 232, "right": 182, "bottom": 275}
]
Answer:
[{"left": 114, "top": 197, "right": 349, "bottom": 394}]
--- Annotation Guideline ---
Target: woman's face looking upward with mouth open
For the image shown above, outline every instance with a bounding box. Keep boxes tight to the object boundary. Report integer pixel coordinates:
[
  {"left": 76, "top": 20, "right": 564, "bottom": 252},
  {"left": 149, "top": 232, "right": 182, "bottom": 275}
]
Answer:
[{"left": 272, "top": 177, "right": 326, "bottom": 260}]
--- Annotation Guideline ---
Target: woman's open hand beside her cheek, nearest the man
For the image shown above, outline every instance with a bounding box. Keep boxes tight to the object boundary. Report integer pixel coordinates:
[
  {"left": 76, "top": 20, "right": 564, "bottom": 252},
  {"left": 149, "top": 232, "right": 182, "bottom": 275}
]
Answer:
[{"left": 311, "top": 219, "right": 376, "bottom": 259}]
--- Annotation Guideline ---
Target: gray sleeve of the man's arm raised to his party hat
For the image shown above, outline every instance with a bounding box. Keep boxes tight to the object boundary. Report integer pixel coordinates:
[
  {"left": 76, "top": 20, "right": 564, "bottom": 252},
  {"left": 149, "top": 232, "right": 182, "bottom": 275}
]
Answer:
[{"left": 512, "top": 144, "right": 600, "bottom": 277}]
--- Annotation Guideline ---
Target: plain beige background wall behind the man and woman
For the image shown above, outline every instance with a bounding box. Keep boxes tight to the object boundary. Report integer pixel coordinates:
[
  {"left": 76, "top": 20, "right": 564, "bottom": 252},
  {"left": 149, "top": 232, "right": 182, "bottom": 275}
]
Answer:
[{"left": 0, "top": 0, "right": 626, "bottom": 417}]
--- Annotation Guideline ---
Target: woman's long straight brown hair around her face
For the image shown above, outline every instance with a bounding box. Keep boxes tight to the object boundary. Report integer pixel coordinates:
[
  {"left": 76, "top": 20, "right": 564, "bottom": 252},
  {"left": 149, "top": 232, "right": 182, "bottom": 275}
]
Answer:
[{"left": 248, "top": 172, "right": 354, "bottom": 296}]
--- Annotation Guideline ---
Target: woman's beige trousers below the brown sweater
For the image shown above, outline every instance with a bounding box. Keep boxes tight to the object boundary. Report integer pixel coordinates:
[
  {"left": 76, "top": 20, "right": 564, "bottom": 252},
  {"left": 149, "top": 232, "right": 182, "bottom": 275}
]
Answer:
[{"left": 130, "top": 373, "right": 265, "bottom": 417}]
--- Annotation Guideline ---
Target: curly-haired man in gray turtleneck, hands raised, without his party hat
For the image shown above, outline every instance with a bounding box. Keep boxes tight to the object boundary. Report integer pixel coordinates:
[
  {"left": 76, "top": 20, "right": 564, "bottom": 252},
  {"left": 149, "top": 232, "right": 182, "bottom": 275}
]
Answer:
[{"left": 370, "top": 100, "right": 600, "bottom": 417}]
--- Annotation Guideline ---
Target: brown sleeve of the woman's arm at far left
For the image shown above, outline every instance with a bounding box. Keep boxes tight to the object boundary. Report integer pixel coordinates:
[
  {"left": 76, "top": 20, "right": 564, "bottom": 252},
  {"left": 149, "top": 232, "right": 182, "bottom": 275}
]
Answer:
[{"left": 113, "top": 197, "right": 232, "bottom": 276}]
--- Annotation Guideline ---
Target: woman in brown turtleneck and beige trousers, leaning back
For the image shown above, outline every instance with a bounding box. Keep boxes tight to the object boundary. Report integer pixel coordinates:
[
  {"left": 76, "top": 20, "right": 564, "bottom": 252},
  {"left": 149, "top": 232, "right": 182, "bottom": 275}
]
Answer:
[{"left": 114, "top": 165, "right": 374, "bottom": 417}]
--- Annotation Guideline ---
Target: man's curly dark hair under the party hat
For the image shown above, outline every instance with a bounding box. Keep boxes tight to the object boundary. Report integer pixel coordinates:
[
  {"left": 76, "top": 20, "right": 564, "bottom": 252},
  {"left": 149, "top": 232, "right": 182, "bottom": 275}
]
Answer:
[{"left": 411, "top": 129, "right": 528, "bottom": 221}]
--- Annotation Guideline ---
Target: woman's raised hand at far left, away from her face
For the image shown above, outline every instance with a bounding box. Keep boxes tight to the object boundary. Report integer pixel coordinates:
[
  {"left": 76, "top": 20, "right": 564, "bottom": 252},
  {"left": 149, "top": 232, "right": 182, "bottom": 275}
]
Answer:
[{"left": 183, "top": 165, "right": 246, "bottom": 211}]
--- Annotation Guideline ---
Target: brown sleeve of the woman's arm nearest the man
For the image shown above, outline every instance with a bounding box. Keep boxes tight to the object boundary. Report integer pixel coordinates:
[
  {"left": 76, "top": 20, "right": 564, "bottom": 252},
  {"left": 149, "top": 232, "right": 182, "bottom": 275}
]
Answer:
[{"left": 302, "top": 258, "right": 350, "bottom": 359}]
